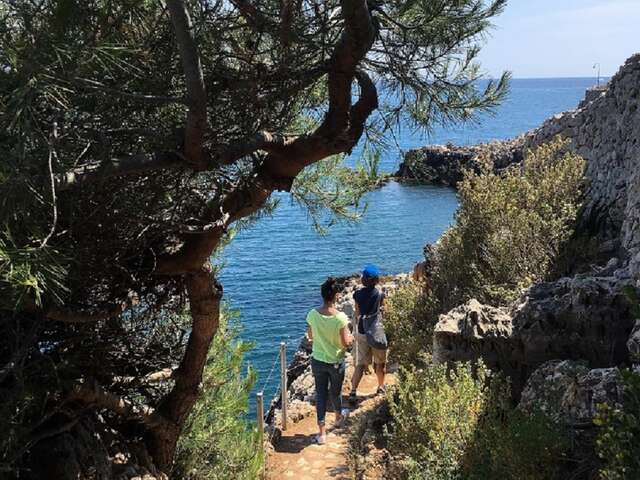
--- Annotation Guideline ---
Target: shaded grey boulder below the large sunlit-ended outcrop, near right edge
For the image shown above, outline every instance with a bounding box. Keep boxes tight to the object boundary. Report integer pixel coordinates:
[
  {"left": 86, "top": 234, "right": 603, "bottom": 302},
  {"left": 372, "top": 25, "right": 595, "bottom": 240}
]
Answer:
[{"left": 519, "top": 360, "right": 623, "bottom": 427}]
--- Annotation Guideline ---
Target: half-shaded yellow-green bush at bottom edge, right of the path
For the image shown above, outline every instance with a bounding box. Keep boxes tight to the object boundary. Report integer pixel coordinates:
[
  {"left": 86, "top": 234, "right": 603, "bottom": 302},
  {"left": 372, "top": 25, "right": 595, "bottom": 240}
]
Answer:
[{"left": 389, "top": 364, "right": 567, "bottom": 480}]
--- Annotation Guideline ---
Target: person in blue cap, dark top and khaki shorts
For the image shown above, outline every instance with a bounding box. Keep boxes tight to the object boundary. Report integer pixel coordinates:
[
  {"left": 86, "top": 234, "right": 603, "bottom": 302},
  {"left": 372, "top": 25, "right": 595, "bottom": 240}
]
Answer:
[{"left": 349, "top": 265, "right": 387, "bottom": 404}]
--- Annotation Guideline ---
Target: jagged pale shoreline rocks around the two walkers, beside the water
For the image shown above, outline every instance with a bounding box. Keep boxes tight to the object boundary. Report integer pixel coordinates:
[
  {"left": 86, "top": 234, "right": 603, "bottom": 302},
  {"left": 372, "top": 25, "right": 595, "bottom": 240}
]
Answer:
[{"left": 265, "top": 273, "right": 410, "bottom": 442}]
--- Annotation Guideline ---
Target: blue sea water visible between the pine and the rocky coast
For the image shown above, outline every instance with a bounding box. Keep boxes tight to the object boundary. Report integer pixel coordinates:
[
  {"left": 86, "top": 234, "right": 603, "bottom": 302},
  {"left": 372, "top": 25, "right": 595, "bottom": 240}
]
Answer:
[{"left": 221, "top": 78, "right": 596, "bottom": 406}]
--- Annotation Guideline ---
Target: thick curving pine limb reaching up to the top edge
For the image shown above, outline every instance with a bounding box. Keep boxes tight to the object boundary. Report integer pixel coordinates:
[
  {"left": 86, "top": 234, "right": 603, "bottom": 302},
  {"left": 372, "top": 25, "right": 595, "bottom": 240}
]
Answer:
[{"left": 156, "top": 0, "right": 378, "bottom": 275}]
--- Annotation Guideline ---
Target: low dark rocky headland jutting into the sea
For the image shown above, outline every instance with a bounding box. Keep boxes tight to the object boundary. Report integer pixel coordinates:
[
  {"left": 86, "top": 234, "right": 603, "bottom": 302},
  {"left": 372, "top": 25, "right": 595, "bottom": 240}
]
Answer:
[{"left": 395, "top": 137, "right": 524, "bottom": 187}]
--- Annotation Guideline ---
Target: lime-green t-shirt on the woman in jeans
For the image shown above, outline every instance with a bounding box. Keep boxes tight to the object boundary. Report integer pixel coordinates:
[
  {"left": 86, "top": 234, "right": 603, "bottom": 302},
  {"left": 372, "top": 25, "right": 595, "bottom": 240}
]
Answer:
[{"left": 307, "top": 309, "right": 349, "bottom": 363}]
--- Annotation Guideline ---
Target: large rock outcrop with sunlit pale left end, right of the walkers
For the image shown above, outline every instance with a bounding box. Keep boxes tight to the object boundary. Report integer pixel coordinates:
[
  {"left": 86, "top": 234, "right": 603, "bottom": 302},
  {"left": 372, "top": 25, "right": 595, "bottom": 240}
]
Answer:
[{"left": 433, "top": 264, "right": 635, "bottom": 397}]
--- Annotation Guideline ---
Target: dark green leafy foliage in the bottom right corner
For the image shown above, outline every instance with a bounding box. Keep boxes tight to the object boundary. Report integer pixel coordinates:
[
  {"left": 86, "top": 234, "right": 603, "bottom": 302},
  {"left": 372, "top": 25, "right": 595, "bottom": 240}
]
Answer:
[{"left": 594, "top": 370, "right": 640, "bottom": 480}]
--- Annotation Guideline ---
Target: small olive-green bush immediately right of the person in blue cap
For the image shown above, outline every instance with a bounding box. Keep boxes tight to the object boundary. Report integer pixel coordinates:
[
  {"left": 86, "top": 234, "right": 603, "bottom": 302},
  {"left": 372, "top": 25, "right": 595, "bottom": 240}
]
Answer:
[{"left": 384, "top": 281, "right": 436, "bottom": 365}]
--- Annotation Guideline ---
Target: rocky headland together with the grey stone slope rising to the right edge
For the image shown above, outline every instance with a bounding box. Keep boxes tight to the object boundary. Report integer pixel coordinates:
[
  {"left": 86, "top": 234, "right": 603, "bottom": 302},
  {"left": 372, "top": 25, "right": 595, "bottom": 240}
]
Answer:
[{"left": 396, "top": 55, "right": 640, "bottom": 262}]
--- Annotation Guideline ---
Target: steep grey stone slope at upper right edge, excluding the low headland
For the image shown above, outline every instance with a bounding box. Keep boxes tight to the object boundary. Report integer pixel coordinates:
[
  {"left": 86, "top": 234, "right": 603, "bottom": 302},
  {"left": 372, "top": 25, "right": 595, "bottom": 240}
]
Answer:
[{"left": 525, "top": 55, "right": 640, "bottom": 253}]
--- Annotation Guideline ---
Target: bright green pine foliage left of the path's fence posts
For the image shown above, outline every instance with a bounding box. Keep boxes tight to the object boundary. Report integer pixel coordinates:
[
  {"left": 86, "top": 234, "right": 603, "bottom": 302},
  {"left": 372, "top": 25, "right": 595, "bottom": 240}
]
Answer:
[{"left": 174, "top": 312, "right": 264, "bottom": 480}]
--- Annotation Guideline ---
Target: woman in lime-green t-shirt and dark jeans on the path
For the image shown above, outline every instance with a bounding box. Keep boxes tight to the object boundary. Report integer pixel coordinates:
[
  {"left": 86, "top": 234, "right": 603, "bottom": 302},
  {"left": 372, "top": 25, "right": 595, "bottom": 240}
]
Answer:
[{"left": 307, "top": 278, "right": 353, "bottom": 445}]
